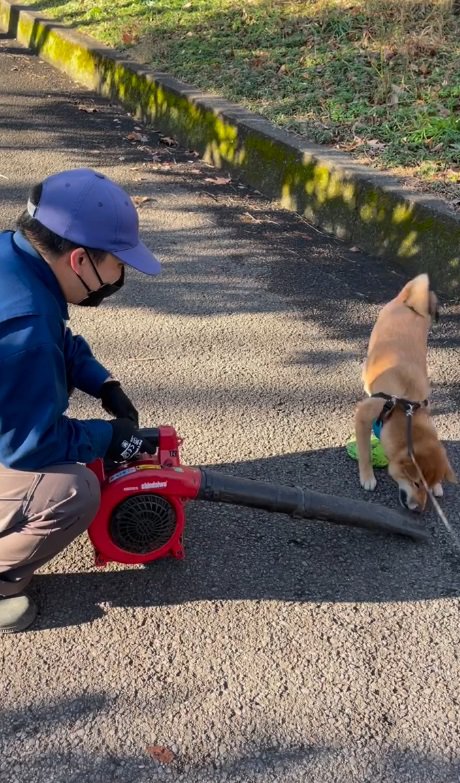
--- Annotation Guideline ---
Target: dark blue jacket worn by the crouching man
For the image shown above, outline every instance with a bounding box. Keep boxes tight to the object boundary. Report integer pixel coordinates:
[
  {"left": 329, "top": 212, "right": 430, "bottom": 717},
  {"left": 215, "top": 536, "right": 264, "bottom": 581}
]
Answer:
[{"left": 0, "top": 231, "right": 112, "bottom": 471}]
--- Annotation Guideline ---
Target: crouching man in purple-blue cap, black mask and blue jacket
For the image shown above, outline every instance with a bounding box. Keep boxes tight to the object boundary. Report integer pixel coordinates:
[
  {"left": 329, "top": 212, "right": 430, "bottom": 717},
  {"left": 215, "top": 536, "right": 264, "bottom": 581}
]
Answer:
[{"left": 0, "top": 169, "right": 160, "bottom": 633}]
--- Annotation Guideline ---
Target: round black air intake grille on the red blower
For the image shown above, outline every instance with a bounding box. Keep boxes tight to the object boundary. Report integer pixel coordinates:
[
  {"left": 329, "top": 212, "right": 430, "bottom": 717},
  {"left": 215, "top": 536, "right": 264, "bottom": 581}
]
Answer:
[{"left": 109, "top": 493, "right": 176, "bottom": 555}]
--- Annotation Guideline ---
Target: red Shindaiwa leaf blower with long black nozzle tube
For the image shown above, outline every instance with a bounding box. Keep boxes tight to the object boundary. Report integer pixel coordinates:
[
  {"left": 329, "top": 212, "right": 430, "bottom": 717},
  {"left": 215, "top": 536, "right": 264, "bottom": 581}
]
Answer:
[{"left": 88, "top": 427, "right": 426, "bottom": 566}]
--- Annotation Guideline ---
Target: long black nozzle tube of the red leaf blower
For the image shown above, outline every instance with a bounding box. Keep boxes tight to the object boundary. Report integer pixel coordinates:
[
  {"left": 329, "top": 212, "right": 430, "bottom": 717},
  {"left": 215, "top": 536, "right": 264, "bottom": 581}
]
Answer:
[{"left": 196, "top": 468, "right": 428, "bottom": 541}]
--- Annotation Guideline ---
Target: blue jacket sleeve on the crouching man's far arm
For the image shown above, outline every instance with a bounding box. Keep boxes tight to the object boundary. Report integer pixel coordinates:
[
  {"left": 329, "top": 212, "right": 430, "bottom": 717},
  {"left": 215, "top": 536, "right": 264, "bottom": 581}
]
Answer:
[{"left": 64, "top": 327, "right": 110, "bottom": 397}]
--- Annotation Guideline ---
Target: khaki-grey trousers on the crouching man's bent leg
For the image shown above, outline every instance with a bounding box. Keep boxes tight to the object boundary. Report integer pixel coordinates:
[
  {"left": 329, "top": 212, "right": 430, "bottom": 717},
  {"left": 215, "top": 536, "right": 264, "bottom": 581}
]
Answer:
[{"left": 0, "top": 464, "right": 100, "bottom": 596}]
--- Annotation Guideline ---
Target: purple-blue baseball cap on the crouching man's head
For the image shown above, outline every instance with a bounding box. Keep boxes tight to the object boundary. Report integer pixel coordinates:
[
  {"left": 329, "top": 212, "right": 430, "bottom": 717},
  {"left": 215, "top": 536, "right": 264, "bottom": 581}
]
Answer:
[{"left": 27, "top": 169, "right": 161, "bottom": 275}]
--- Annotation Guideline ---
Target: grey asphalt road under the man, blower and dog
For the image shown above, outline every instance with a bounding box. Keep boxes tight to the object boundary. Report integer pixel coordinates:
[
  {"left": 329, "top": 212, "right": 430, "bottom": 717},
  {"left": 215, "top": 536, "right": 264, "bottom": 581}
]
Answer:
[{"left": 0, "top": 30, "right": 460, "bottom": 783}]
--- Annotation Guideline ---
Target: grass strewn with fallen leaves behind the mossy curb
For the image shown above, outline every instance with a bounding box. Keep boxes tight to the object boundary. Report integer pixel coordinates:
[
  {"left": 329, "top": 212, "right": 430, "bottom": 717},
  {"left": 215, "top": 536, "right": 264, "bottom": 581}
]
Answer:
[{"left": 28, "top": 0, "right": 460, "bottom": 200}]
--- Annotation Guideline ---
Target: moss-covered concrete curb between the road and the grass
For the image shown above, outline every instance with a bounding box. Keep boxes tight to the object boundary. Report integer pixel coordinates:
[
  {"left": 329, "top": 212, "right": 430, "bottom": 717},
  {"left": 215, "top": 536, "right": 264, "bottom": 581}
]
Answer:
[{"left": 0, "top": 0, "right": 460, "bottom": 297}]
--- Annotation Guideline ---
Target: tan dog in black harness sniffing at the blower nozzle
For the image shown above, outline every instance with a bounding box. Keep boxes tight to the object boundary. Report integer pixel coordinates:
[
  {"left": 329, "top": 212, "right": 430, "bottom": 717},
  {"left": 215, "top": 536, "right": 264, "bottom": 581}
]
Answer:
[{"left": 355, "top": 274, "right": 456, "bottom": 511}]
